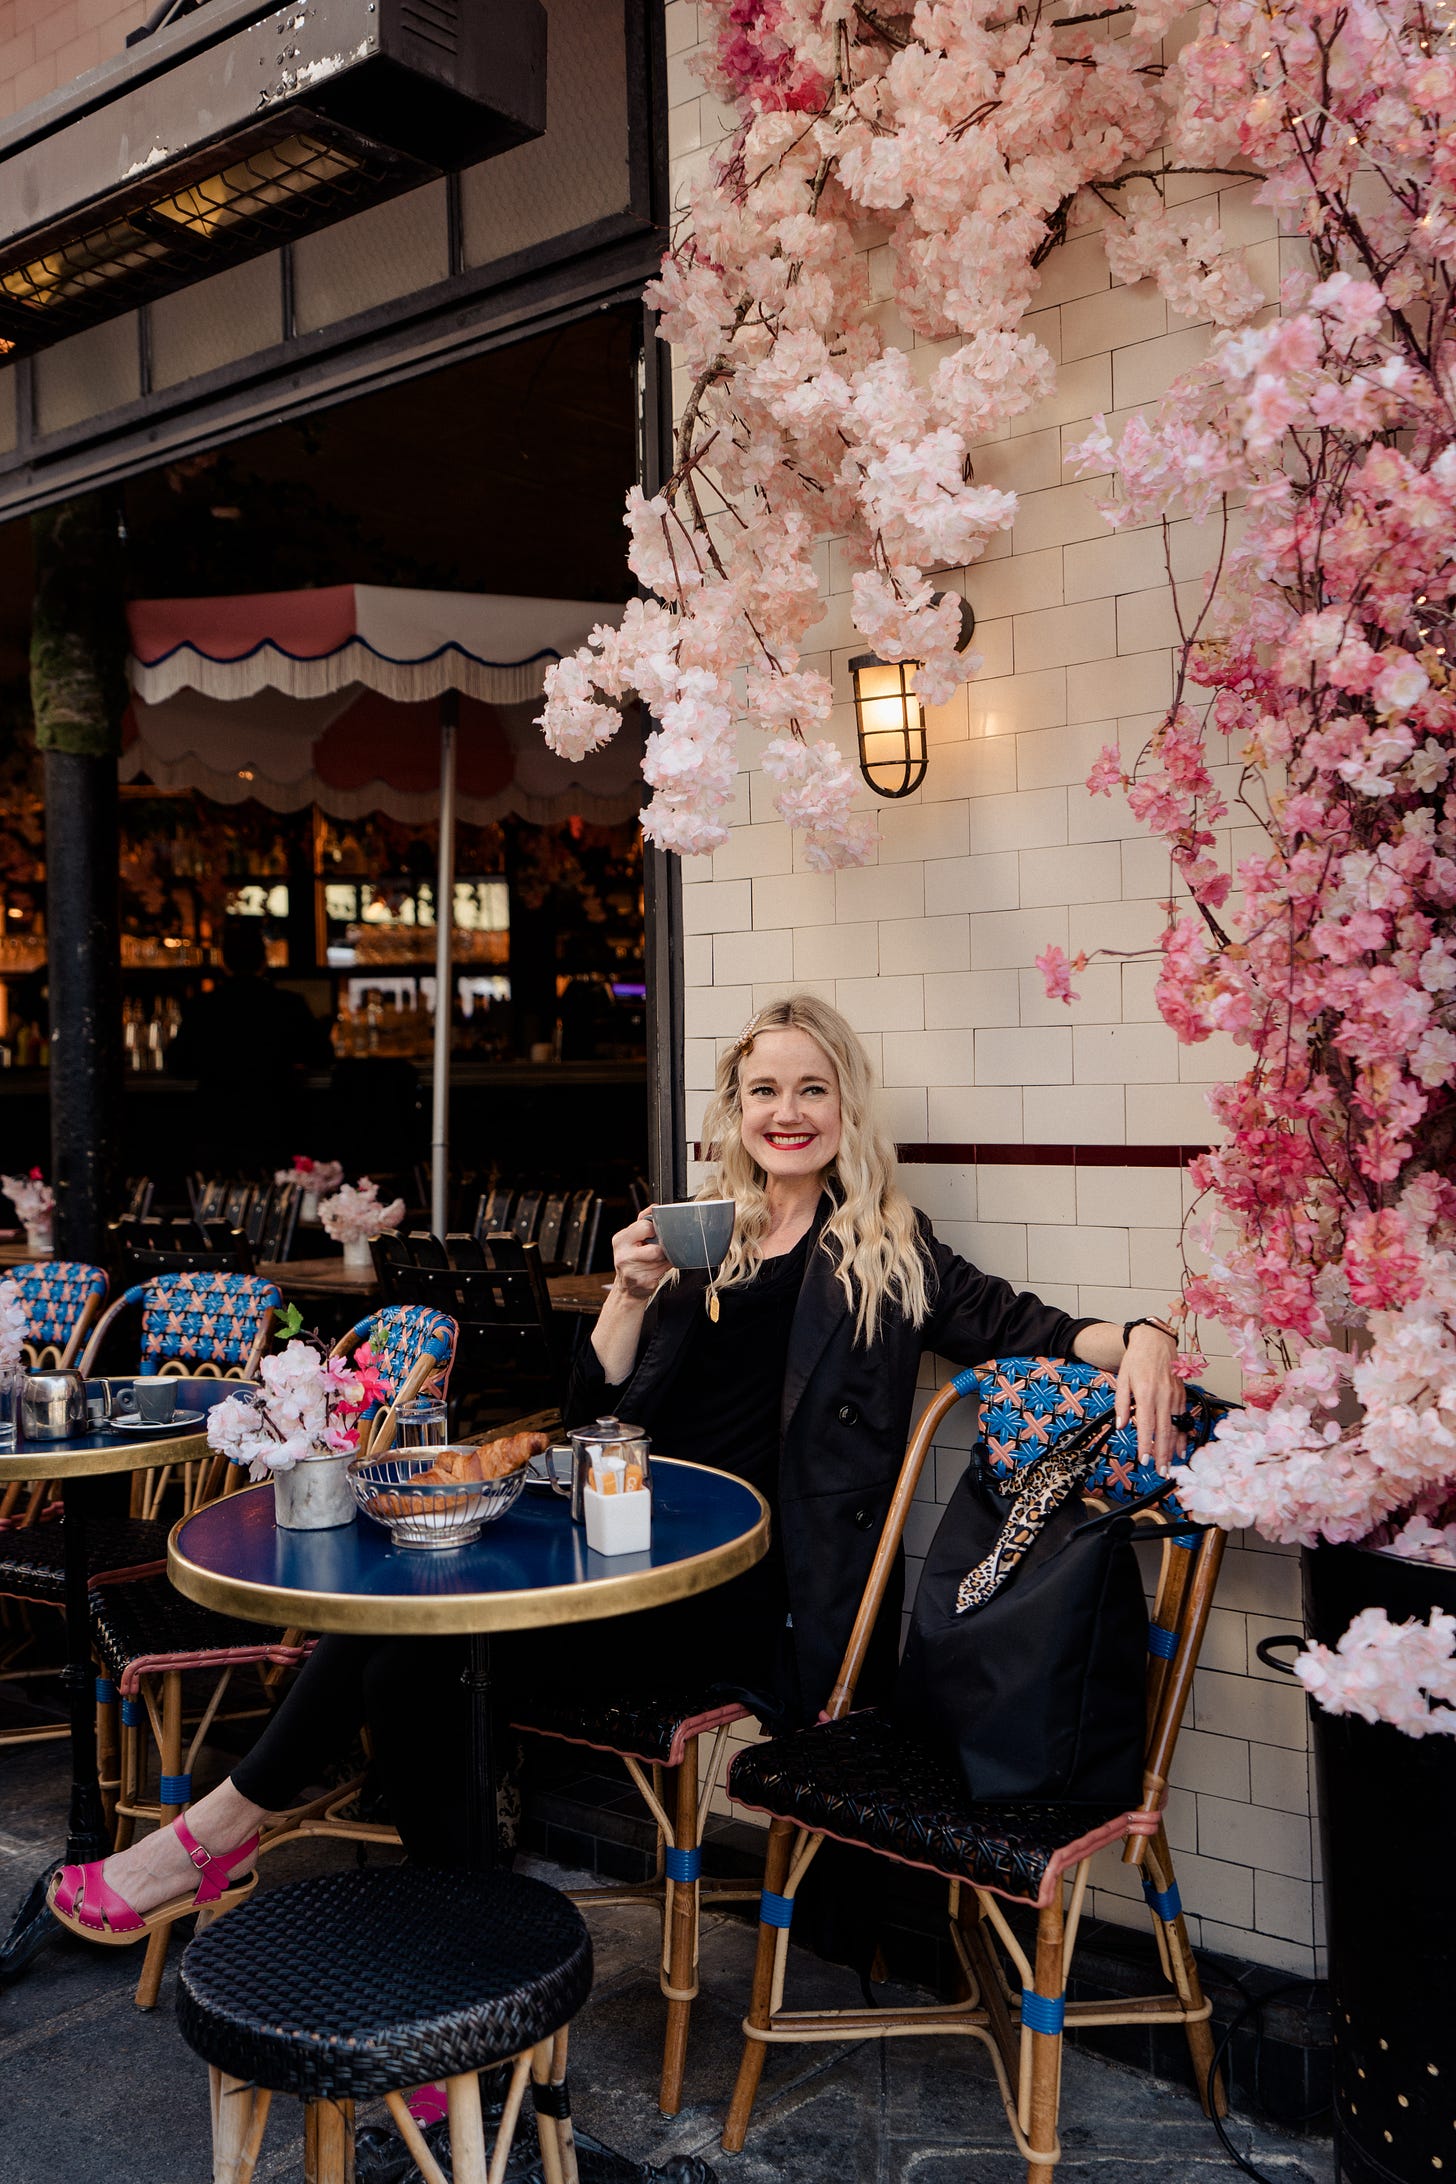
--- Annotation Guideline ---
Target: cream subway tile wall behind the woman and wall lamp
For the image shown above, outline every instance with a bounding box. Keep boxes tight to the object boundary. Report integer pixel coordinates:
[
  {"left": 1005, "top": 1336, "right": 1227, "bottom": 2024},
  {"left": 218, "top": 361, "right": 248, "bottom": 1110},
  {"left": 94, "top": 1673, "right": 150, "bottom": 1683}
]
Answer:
[{"left": 666, "top": 0, "right": 1321, "bottom": 1972}]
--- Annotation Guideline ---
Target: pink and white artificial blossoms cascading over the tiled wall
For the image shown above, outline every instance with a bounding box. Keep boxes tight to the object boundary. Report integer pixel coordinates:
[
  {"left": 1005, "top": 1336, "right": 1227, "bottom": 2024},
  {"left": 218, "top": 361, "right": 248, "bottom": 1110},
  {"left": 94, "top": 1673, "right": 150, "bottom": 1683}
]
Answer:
[{"left": 541, "top": 0, "right": 1456, "bottom": 1734}]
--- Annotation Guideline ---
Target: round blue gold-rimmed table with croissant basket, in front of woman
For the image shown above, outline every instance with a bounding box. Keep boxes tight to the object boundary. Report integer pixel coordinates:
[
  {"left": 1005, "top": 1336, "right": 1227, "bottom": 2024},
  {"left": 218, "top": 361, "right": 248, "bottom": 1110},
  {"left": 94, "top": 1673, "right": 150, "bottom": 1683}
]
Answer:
[{"left": 168, "top": 1457, "right": 768, "bottom": 1867}]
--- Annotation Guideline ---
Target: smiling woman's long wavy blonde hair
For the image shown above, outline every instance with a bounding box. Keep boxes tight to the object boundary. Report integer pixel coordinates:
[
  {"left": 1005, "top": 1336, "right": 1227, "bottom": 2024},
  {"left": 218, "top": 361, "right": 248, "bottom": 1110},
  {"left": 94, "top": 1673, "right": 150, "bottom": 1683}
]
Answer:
[{"left": 699, "top": 994, "right": 930, "bottom": 1343}]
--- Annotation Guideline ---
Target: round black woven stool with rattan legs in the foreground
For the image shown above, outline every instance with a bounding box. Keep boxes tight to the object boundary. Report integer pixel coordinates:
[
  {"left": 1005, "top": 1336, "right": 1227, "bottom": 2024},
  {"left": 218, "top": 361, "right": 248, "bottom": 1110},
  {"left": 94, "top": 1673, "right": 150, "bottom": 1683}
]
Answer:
[{"left": 177, "top": 1865, "right": 592, "bottom": 2184}]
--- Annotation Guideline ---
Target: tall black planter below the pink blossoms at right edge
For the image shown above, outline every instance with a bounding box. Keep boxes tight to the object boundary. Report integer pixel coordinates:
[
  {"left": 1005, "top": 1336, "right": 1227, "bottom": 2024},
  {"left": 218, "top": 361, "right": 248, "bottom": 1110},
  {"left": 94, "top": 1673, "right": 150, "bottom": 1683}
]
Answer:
[{"left": 1305, "top": 1546, "right": 1456, "bottom": 2184}]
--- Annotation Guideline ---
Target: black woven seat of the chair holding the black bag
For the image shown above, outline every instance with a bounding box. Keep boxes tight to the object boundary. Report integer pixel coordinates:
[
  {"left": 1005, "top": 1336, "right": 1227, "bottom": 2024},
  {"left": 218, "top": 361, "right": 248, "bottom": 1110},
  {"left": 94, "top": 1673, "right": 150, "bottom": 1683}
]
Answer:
[{"left": 727, "top": 1708, "right": 1129, "bottom": 1904}]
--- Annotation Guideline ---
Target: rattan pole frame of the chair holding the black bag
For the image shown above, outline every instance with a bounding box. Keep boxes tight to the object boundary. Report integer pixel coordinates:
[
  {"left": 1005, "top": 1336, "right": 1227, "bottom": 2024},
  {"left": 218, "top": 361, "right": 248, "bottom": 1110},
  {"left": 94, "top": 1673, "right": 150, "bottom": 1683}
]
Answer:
[{"left": 723, "top": 1372, "right": 1225, "bottom": 2184}]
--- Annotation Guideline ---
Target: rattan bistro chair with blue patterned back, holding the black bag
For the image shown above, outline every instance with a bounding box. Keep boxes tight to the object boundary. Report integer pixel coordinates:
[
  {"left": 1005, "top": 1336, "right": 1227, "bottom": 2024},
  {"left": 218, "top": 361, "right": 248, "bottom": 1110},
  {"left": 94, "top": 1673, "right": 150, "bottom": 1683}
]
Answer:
[{"left": 723, "top": 1358, "right": 1225, "bottom": 2184}]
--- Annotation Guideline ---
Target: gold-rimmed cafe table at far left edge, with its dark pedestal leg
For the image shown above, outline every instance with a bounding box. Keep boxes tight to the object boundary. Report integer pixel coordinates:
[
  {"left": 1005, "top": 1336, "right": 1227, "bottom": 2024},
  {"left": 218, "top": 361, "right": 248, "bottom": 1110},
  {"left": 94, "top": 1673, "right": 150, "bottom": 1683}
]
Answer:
[{"left": 0, "top": 1378, "right": 238, "bottom": 1979}]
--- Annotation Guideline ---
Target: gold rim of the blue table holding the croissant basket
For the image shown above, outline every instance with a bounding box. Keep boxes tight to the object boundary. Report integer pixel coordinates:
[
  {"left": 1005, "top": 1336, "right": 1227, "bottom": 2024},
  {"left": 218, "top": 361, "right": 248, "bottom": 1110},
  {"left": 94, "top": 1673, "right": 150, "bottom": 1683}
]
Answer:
[{"left": 166, "top": 1457, "right": 768, "bottom": 1638}]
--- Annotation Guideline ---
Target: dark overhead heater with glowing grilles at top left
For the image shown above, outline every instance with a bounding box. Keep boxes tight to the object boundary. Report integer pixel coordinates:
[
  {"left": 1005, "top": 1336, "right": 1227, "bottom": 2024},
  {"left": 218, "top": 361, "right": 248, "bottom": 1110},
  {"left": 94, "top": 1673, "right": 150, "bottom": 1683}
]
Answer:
[{"left": 0, "top": 0, "right": 546, "bottom": 354}]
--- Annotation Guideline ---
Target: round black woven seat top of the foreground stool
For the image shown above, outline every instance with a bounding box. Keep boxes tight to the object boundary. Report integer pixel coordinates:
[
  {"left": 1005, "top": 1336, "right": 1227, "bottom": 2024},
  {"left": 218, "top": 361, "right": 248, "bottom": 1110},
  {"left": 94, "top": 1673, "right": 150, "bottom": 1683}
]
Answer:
[{"left": 177, "top": 1865, "right": 592, "bottom": 2101}]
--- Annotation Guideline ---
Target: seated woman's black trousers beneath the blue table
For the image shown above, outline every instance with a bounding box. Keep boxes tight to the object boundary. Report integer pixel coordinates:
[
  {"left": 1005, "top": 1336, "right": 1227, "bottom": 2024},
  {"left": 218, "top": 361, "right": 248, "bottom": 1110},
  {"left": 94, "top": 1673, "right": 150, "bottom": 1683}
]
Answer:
[{"left": 234, "top": 1557, "right": 786, "bottom": 1865}]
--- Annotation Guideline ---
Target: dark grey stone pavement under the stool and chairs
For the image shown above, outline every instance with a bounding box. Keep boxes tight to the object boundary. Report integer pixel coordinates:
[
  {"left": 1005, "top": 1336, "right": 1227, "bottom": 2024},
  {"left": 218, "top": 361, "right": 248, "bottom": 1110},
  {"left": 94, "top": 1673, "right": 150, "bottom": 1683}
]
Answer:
[{"left": 0, "top": 1745, "right": 1332, "bottom": 2184}]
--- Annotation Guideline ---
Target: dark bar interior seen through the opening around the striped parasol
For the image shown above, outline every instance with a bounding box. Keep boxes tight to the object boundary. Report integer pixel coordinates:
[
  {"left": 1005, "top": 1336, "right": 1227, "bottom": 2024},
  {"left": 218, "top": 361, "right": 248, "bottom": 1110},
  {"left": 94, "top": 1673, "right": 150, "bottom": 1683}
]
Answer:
[{"left": 0, "top": 306, "right": 648, "bottom": 1216}]
